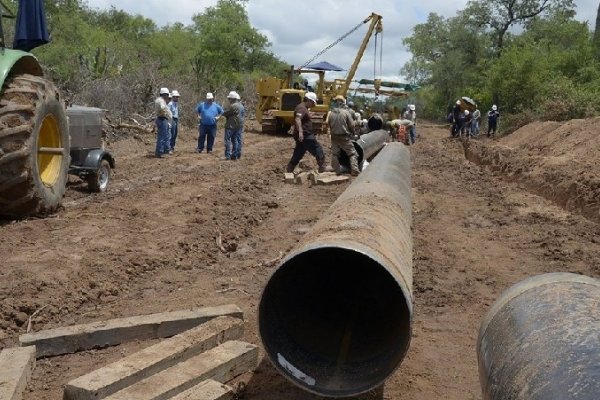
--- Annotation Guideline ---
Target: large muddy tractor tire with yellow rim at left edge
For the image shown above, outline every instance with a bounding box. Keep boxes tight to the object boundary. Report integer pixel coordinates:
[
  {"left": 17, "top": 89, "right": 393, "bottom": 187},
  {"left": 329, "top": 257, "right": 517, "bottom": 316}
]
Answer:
[{"left": 0, "top": 74, "right": 70, "bottom": 218}]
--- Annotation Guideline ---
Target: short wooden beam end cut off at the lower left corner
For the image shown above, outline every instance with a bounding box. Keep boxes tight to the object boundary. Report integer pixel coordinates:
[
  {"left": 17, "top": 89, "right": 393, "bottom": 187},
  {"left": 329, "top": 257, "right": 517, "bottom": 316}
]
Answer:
[{"left": 0, "top": 346, "right": 35, "bottom": 400}]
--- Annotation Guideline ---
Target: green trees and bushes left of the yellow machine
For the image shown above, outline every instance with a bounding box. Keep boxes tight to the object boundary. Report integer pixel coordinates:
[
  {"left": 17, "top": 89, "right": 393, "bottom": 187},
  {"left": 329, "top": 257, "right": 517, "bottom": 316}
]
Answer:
[{"left": 9, "top": 0, "right": 286, "bottom": 122}]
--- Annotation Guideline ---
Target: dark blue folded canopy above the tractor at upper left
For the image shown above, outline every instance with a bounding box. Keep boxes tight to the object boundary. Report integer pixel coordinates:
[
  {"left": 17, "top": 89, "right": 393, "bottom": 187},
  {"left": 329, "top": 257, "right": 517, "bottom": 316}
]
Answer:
[{"left": 13, "top": 0, "right": 50, "bottom": 51}]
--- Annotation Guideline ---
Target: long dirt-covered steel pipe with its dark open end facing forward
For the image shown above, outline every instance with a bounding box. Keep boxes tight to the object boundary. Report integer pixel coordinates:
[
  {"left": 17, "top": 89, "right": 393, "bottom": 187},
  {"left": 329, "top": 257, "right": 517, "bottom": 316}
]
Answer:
[{"left": 259, "top": 143, "right": 412, "bottom": 397}]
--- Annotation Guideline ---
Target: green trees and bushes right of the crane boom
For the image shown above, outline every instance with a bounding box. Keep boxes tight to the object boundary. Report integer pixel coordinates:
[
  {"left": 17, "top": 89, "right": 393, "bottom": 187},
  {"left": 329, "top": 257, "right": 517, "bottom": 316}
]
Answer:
[{"left": 402, "top": 0, "right": 600, "bottom": 125}]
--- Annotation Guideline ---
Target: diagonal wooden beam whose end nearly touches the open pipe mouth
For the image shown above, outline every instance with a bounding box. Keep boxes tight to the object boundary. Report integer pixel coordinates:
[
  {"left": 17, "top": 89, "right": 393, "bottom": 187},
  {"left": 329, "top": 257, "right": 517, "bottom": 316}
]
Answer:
[{"left": 106, "top": 341, "right": 258, "bottom": 400}]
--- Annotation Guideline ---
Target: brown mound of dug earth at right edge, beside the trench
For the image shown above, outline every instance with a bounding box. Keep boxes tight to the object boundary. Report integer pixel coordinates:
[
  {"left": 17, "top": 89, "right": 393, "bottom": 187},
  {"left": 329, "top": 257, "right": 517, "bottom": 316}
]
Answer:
[{"left": 465, "top": 118, "right": 600, "bottom": 221}]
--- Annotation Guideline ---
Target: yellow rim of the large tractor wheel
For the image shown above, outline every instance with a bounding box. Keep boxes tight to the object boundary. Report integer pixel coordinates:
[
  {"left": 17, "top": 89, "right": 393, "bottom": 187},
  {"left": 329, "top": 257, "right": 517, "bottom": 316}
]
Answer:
[{"left": 37, "top": 115, "right": 63, "bottom": 187}]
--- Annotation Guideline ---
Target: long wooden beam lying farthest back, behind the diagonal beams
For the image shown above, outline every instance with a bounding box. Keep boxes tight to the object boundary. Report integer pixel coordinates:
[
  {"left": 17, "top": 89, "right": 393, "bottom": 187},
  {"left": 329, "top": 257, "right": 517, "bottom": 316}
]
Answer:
[{"left": 19, "top": 304, "right": 243, "bottom": 358}]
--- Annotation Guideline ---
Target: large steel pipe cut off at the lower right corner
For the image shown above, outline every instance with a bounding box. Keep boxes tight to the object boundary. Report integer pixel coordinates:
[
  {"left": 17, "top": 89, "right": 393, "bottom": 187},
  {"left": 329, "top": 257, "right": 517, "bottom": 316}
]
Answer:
[{"left": 477, "top": 273, "right": 600, "bottom": 400}]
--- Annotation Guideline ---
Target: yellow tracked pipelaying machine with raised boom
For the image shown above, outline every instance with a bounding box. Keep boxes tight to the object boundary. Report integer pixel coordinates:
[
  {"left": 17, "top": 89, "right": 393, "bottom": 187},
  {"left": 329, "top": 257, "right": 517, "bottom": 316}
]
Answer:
[{"left": 256, "top": 13, "right": 383, "bottom": 133}]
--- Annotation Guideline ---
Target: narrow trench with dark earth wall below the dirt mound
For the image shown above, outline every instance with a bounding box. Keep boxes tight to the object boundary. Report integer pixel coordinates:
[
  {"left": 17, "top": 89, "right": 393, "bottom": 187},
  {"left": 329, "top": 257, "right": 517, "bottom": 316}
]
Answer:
[{"left": 462, "top": 140, "right": 600, "bottom": 222}]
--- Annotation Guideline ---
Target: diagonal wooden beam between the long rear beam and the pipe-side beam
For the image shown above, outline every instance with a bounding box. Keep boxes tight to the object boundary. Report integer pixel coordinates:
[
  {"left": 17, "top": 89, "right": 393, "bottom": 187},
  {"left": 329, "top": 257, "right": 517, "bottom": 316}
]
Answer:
[{"left": 64, "top": 317, "right": 244, "bottom": 400}]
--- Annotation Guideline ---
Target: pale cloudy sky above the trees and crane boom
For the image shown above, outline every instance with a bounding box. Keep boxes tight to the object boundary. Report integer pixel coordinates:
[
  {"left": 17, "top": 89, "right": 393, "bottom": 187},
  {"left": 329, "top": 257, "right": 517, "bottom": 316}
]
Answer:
[{"left": 87, "top": 0, "right": 598, "bottom": 83}]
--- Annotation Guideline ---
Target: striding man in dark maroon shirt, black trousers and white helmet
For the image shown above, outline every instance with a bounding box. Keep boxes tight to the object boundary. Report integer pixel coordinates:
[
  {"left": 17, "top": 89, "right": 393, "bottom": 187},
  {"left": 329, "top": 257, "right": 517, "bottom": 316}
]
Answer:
[{"left": 286, "top": 92, "right": 333, "bottom": 172}]
